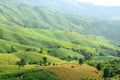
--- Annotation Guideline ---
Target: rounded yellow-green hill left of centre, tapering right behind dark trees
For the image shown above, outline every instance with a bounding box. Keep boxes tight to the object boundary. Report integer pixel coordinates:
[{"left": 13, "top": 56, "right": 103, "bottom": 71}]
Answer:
[{"left": 15, "top": 51, "right": 65, "bottom": 64}]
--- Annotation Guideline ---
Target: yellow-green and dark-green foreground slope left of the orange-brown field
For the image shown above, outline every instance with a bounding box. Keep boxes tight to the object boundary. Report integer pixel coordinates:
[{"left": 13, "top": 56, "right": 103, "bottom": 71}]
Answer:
[{"left": 0, "top": 65, "right": 59, "bottom": 80}]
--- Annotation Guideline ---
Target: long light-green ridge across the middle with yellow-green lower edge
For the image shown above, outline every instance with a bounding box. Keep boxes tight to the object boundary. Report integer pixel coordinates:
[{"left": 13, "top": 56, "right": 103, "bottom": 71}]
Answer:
[{"left": 0, "top": 25, "right": 117, "bottom": 53}]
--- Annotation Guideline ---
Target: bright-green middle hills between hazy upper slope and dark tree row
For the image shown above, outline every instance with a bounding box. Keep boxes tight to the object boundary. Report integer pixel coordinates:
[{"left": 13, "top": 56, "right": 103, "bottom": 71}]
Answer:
[{"left": 0, "top": 20, "right": 119, "bottom": 59}]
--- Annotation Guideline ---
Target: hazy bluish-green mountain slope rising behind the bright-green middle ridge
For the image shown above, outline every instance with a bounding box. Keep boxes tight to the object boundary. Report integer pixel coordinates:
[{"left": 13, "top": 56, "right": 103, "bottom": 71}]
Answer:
[{"left": 0, "top": 0, "right": 120, "bottom": 45}]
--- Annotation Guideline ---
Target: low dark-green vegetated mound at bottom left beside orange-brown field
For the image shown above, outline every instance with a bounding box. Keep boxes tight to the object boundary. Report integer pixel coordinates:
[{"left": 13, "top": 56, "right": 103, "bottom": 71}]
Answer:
[{"left": 0, "top": 69, "right": 59, "bottom": 80}]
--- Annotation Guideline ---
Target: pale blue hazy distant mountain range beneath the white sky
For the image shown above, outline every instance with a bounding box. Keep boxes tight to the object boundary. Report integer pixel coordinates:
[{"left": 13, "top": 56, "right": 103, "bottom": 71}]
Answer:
[{"left": 18, "top": 0, "right": 120, "bottom": 20}]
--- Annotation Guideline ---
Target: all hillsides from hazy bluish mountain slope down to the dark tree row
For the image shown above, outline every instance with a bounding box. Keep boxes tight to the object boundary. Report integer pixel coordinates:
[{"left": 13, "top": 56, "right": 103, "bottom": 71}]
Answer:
[{"left": 0, "top": 0, "right": 120, "bottom": 62}]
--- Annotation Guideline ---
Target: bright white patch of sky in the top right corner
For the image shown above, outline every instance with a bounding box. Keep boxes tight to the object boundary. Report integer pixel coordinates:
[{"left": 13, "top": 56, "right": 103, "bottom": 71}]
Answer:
[{"left": 78, "top": 0, "right": 120, "bottom": 6}]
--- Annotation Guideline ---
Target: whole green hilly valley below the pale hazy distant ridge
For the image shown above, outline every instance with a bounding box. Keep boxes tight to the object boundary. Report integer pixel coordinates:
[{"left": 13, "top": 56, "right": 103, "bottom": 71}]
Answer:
[{"left": 0, "top": 0, "right": 120, "bottom": 80}]
